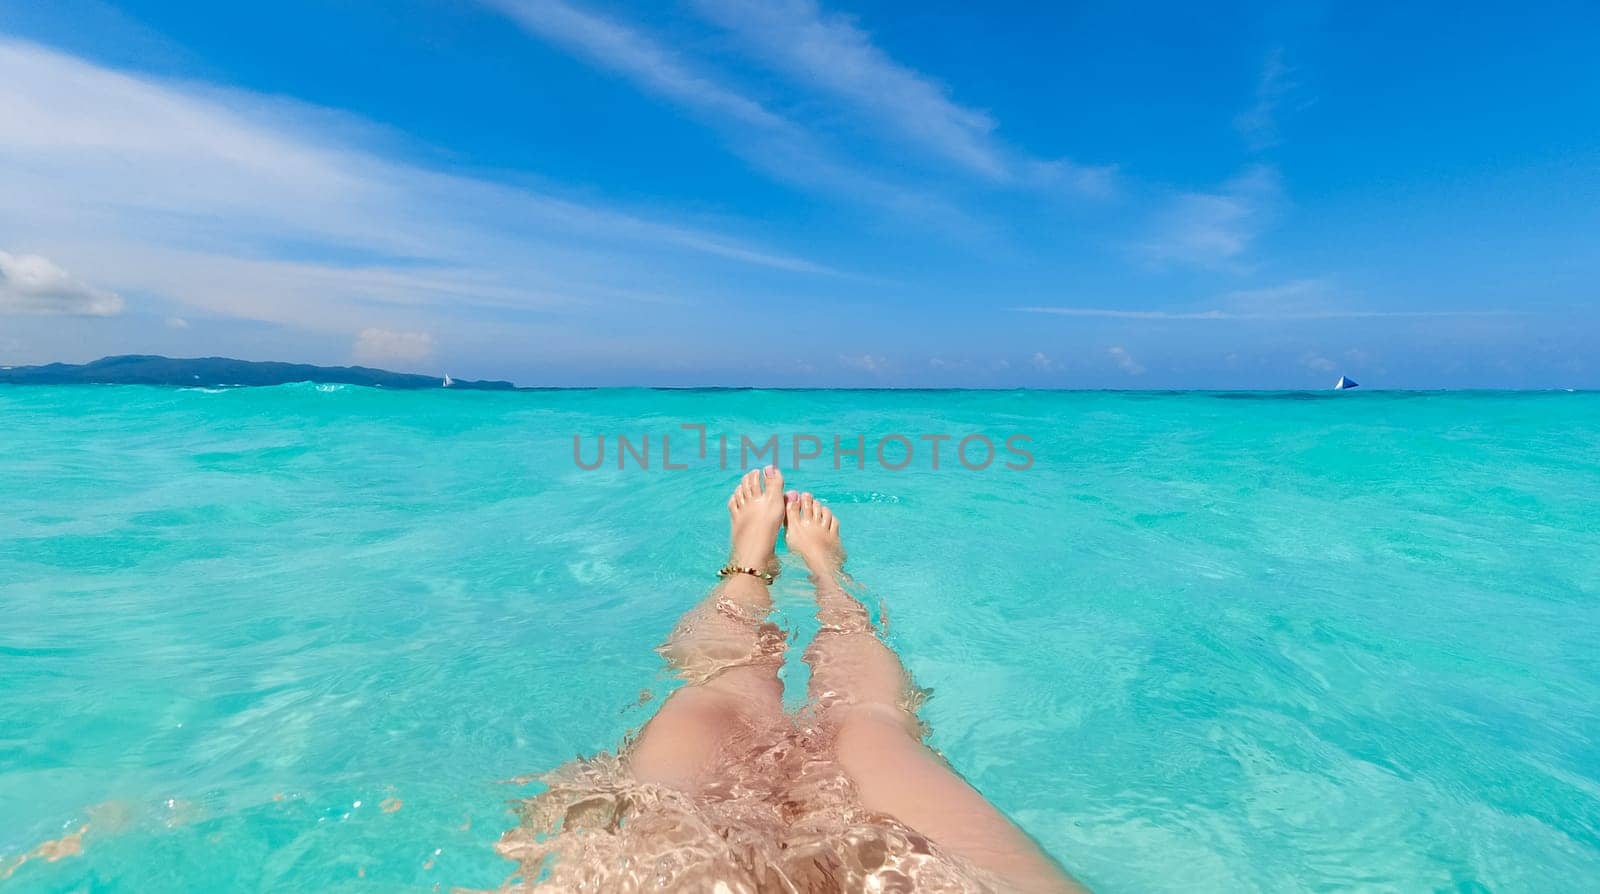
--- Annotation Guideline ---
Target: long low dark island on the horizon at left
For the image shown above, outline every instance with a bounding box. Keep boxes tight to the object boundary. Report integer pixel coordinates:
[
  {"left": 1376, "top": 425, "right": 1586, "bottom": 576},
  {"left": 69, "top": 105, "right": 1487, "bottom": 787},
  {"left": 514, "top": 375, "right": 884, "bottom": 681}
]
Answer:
[{"left": 0, "top": 353, "right": 517, "bottom": 392}]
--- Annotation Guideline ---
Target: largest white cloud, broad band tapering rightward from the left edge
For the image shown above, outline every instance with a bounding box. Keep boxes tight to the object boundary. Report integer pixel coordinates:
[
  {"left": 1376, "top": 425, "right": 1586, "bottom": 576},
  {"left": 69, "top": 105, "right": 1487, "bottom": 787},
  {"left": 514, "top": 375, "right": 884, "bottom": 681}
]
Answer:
[{"left": 0, "top": 38, "right": 834, "bottom": 342}]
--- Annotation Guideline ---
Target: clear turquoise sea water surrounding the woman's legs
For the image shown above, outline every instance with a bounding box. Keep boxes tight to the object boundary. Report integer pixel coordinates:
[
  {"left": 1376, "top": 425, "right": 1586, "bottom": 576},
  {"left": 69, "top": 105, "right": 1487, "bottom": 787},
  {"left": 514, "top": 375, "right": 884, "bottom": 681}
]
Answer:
[{"left": 0, "top": 385, "right": 1600, "bottom": 892}]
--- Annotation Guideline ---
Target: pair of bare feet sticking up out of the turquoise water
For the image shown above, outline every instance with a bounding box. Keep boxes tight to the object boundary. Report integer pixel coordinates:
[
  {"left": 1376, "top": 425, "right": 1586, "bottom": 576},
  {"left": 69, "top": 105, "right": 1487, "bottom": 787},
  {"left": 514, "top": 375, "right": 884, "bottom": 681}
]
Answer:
[{"left": 728, "top": 465, "right": 845, "bottom": 585}]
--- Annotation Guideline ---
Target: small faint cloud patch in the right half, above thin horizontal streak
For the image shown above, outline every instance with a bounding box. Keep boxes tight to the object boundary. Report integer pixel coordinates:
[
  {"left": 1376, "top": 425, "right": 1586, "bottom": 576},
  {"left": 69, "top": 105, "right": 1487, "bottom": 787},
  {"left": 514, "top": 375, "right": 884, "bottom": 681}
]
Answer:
[{"left": 1142, "top": 165, "right": 1282, "bottom": 267}]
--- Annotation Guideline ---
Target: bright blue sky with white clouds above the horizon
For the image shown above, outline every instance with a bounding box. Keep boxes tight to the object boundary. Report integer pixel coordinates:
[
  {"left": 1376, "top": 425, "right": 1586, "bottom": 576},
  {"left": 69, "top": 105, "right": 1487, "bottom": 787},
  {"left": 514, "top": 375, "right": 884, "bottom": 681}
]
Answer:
[{"left": 0, "top": 0, "right": 1600, "bottom": 389}]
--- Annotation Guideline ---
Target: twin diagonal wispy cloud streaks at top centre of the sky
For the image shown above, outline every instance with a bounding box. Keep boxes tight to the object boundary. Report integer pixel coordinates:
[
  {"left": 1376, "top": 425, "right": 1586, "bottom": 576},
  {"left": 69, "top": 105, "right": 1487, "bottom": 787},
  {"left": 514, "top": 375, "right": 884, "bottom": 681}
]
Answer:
[{"left": 478, "top": 0, "right": 1114, "bottom": 227}]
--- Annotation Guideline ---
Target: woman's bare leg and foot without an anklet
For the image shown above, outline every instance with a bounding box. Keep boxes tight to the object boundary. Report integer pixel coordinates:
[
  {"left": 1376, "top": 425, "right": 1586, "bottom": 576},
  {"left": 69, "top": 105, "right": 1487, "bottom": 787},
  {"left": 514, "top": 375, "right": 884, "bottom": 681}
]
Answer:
[{"left": 786, "top": 494, "right": 1082, "bottom": 892}]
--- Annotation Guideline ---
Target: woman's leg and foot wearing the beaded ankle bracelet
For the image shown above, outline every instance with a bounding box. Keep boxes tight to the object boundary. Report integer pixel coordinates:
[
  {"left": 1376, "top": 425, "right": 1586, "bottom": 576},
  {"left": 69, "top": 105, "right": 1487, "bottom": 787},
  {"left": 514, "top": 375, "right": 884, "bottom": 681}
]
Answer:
[{"left": 626, "top": 467, "right": 787, "bottom": 793}]
